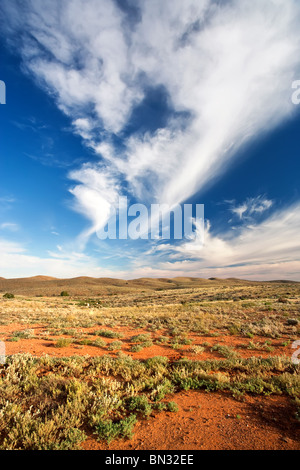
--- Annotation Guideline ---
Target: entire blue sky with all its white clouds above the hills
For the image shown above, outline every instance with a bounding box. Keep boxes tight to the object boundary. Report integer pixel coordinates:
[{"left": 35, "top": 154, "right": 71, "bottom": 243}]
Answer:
[{"left": 0, "top": 0, "right": 300, "bottom": 280}]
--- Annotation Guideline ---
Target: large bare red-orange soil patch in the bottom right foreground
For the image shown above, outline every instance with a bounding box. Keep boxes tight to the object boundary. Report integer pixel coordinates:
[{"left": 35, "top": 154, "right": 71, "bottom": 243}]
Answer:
[{"left": 82, "top": 391, "right": 300, "bottom": 450}]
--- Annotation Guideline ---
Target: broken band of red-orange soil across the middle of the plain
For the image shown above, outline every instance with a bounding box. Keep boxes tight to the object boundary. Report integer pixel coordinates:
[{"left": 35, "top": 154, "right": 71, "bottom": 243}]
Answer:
[{"left": 0, "top": 323, "right": 293, "bottom": 360}]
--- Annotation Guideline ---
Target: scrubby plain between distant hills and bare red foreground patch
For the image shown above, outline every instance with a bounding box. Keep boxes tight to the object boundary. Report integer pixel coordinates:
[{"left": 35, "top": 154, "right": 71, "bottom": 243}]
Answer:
[{"left": 0, "top": 280, "right": 300, "bottom": 450}]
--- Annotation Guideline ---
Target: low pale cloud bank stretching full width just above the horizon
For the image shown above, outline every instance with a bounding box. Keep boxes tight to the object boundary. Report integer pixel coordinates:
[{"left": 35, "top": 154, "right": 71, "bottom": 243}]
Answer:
[{"left": 0, "top": 203, "right": 300, "bottom": 281}]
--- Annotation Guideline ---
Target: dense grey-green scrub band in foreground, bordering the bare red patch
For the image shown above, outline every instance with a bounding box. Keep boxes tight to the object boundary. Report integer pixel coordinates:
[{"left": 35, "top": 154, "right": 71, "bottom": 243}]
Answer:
[{"left": 0, "top": 353, "right": 300, "bottom": 450}]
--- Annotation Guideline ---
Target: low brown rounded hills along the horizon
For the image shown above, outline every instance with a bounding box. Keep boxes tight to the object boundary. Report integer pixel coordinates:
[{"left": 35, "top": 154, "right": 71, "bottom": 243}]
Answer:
[{"left": 0, "top": 276, "right": 295, "bottom": 296}]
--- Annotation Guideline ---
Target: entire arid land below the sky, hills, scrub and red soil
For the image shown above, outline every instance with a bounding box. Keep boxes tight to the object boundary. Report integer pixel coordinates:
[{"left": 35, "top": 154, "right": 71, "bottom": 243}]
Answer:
[{"left": 0, "top": 276, "right": 300, "bottom": 450}]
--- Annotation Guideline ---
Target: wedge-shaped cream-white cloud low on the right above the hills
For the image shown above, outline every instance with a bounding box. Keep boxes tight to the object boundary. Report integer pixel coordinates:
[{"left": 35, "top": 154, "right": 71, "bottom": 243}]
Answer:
[{"left": 140, "top": 203, "right": 300, "bottom": 280}]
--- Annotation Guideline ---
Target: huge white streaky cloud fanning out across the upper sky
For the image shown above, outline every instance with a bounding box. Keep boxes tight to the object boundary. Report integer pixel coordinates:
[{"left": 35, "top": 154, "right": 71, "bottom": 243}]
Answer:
[{"left": 2, "top": 0, "right": 300, "bottom": 239}]
